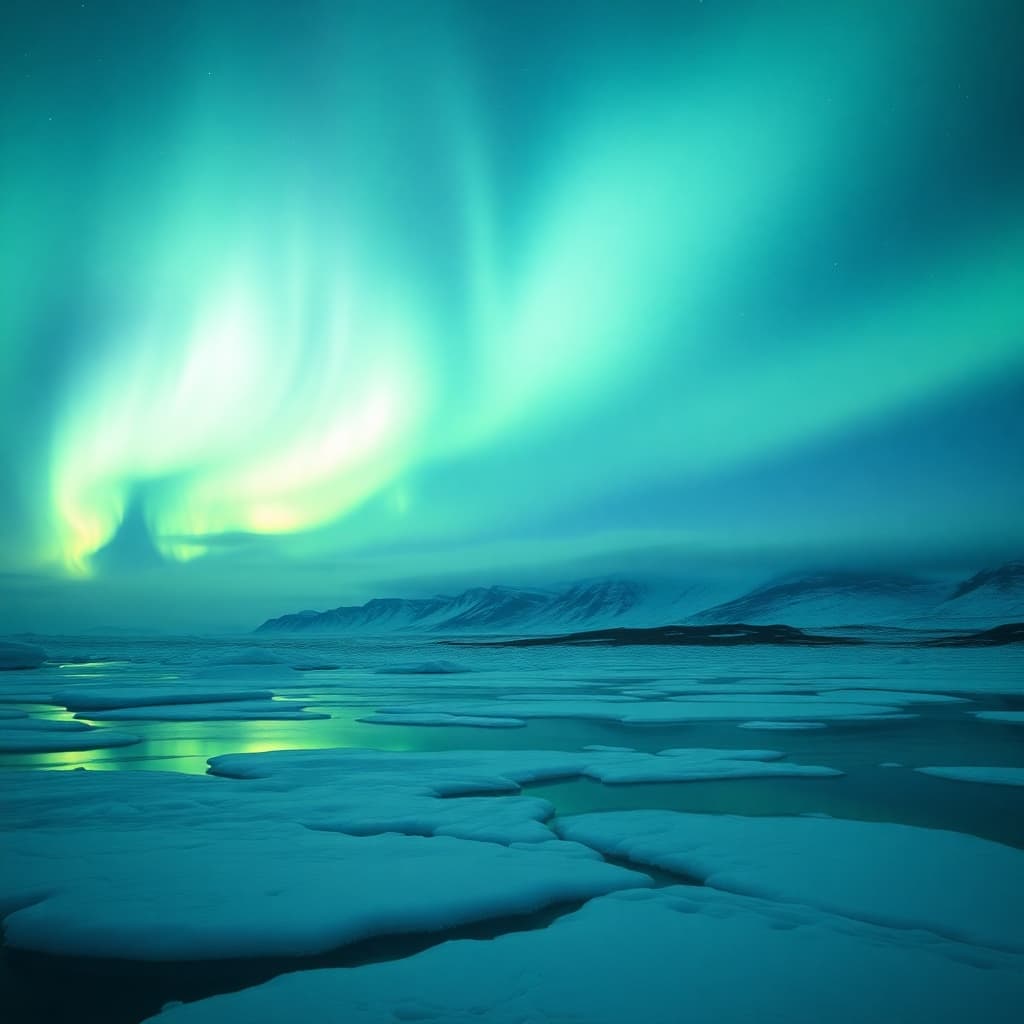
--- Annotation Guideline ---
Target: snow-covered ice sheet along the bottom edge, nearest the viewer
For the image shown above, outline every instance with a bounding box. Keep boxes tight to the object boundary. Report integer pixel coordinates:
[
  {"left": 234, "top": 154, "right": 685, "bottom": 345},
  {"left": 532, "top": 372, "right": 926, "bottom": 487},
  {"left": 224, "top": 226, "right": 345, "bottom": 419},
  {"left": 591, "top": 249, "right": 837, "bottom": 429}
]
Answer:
[{"left": 142, "top": 886, "right": 1024, "bottom": 1024}]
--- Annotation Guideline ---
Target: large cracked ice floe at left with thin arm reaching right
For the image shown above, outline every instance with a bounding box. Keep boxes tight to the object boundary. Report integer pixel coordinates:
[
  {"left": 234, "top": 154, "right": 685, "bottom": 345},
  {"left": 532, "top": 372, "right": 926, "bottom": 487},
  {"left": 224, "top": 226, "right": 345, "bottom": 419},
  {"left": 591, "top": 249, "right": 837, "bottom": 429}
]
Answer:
[{"left": 0, "top": 745, "right": 839, "bottom": 958}]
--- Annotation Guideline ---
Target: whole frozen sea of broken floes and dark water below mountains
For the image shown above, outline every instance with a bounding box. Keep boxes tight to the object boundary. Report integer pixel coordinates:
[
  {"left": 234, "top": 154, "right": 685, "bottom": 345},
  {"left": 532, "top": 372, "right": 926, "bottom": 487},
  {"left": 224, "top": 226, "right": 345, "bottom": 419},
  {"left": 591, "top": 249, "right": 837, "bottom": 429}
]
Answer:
[{"left": 0, "top": 636, "right": 1024, "bottom": 1024}]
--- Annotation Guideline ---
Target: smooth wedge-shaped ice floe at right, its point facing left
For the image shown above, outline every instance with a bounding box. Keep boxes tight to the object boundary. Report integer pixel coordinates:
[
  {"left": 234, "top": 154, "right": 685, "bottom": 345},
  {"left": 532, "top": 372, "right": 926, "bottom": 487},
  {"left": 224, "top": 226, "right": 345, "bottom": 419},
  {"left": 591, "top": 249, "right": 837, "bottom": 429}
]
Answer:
[{"left": 557, "top": 811, "right": 1024, "bottom": 952}]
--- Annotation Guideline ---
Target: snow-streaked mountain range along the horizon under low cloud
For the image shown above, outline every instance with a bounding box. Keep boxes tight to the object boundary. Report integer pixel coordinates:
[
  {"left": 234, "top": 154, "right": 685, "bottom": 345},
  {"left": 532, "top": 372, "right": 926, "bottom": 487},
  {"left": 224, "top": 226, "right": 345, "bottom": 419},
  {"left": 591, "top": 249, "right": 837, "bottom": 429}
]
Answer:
[{"left": 258, "top": 561, "right": 1024, "bottom": 635}]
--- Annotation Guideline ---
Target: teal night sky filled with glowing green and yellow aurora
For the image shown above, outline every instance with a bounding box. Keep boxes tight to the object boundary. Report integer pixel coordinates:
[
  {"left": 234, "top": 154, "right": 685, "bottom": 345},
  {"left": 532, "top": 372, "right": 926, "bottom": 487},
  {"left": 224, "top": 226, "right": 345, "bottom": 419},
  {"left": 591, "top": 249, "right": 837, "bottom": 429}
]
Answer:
[{"left": 0, "top": 0, "right": 1024, "bottom": 629}]
